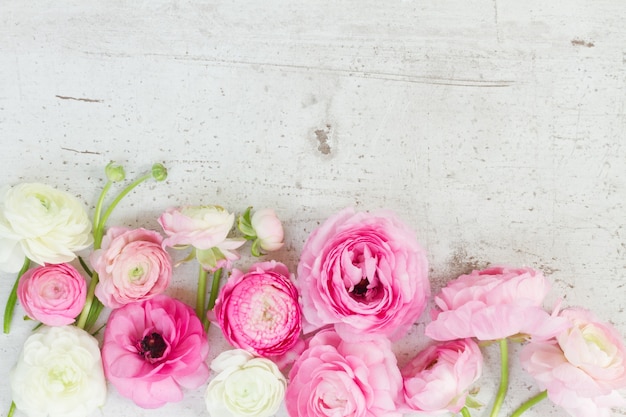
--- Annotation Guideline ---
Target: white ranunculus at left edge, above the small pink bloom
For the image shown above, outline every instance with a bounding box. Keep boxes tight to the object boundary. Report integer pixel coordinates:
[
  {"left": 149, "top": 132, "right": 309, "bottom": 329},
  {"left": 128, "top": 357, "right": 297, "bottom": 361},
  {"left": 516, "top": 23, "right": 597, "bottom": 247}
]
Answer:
[{"left": 0, "top": 183, "right": 93, "bottom": 272}]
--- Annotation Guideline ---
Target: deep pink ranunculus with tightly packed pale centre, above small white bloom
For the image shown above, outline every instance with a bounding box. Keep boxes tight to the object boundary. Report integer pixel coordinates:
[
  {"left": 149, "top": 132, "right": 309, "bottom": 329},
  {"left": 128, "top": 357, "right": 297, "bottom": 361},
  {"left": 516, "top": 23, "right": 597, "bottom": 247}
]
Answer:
[{"left": 214, "top": 261, "right": 302, "bottom": 357}]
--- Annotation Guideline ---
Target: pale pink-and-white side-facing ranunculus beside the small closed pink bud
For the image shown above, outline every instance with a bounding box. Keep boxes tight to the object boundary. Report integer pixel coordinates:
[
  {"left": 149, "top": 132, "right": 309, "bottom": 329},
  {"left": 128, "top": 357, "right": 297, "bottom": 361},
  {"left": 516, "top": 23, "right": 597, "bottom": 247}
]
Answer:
[{"left": 158, "top": 206, "right": 246, "bottom": 271}]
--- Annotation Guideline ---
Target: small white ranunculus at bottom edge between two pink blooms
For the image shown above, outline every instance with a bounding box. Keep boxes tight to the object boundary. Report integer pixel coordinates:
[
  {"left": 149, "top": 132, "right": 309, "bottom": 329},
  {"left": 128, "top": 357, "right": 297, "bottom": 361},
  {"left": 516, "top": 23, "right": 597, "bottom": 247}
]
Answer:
[{"left": 204, "top": 349, "right": 287, "bottom": 417}]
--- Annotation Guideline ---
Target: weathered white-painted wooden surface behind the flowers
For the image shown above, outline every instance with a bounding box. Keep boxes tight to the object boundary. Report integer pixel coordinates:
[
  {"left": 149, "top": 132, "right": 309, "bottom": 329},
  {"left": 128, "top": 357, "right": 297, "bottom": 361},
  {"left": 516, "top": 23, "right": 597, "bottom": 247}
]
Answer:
[{"left": 0, "top": 0, "right": 626, "bottom": 417}]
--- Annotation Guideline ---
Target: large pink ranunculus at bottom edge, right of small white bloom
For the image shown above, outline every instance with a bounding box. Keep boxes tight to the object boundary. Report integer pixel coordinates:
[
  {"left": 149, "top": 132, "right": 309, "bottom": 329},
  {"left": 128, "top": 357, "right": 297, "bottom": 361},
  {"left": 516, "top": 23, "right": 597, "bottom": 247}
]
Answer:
[{"left": 285, "top": 329, "right": 402, "bottom": 417}]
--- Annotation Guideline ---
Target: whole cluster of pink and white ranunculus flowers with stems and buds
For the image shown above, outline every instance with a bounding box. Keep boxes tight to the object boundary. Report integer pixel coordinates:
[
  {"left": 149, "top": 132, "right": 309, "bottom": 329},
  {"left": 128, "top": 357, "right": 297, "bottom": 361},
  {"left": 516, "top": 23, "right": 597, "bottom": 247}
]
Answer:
[{"left": 0, "top": 164, "right": 626, "bottom": 417}]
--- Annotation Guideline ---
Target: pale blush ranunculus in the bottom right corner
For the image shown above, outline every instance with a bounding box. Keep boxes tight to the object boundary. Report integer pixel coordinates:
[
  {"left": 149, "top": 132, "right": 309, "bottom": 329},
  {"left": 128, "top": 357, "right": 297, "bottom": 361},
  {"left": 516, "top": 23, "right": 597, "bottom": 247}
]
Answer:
[{"left": 520, "top": 308, "right": 626, "bottom": 417}]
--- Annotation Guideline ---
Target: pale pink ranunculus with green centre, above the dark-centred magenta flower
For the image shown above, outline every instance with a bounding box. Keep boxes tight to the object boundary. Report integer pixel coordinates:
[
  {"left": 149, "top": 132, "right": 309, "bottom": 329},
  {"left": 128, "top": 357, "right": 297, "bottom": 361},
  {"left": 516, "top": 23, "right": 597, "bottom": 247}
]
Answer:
[{"left": 90, "top": 227, "right": 172, "bottom": 308}]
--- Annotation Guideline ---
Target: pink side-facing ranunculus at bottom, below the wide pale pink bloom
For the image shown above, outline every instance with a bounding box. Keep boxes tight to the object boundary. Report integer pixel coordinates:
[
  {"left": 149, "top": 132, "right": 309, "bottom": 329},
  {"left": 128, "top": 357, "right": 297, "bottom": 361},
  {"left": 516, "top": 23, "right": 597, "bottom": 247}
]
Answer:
[{"left": 402, "top": 339, "right": 483, "bottom": 414}]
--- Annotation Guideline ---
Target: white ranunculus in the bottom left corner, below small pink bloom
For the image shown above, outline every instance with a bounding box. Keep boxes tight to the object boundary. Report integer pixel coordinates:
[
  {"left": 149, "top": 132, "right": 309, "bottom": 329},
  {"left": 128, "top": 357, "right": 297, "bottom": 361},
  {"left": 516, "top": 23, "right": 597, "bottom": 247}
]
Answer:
[{"left": 9, "top": 325, "right": 106, "bottom": 417}]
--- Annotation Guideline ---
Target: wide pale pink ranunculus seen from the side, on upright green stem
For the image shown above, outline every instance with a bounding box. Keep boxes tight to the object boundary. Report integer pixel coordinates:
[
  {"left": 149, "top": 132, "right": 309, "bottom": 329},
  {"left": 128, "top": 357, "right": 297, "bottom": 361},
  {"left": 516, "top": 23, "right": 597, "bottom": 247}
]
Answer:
[{"left": 425, "top": 267, "right": 568, "bottom": 340}]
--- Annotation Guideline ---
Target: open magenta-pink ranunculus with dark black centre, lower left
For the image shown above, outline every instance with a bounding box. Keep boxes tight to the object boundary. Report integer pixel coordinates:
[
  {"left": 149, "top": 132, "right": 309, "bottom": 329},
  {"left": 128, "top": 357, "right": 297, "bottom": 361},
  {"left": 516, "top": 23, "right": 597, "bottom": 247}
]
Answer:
[{"left": 102, "top": 295, "right": 209, "bottom": 408}]
